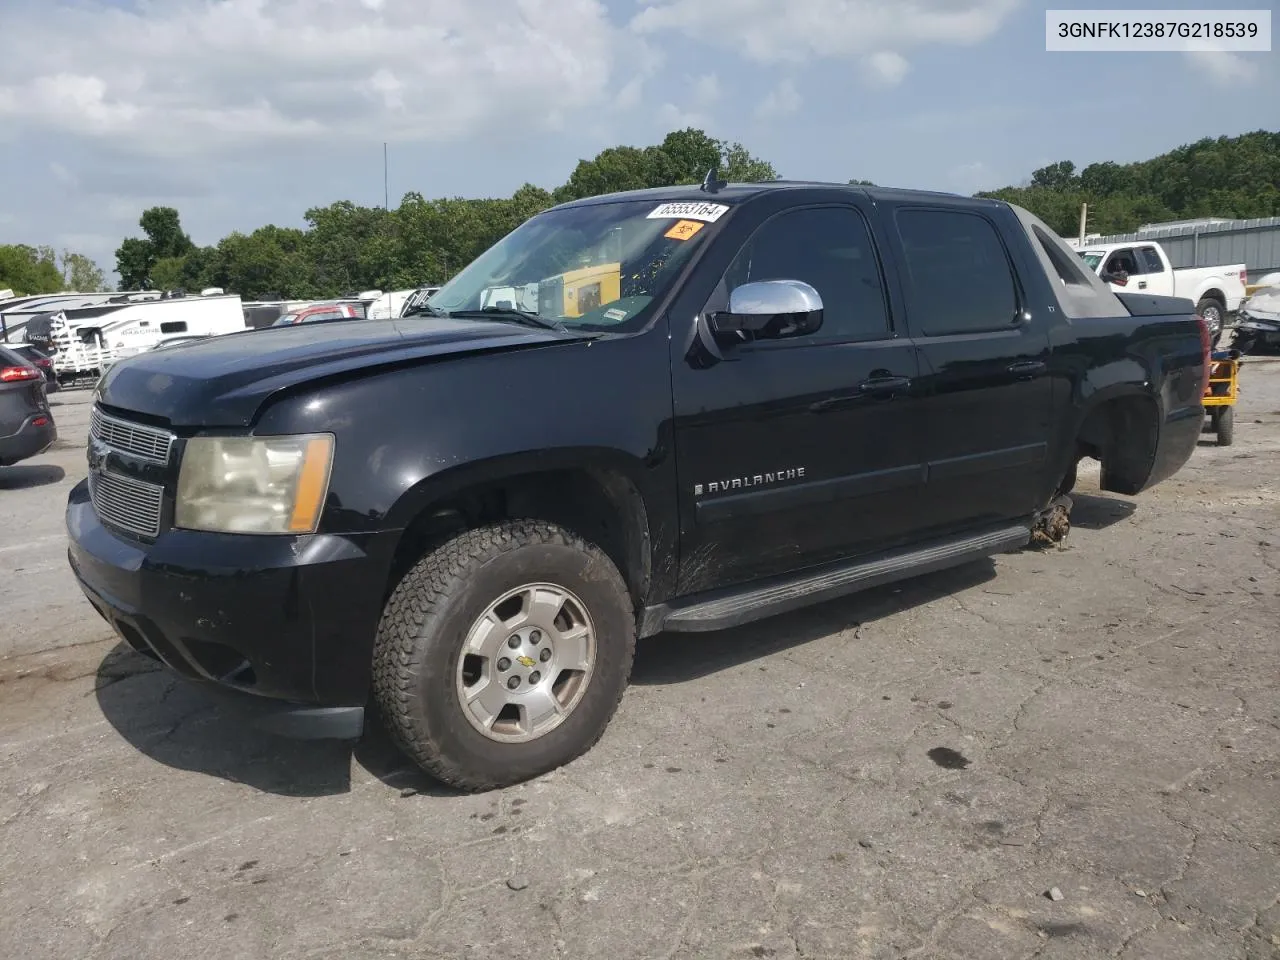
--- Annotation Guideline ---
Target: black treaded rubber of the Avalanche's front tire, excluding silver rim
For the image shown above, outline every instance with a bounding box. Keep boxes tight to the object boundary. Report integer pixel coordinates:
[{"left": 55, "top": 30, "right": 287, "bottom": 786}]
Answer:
[{"left": 372, "top": 520, "right": 636, "bottom": 791}]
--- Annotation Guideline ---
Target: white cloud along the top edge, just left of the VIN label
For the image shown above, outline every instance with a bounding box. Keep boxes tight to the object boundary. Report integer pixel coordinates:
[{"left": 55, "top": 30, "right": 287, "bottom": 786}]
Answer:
[{"left": 631, "top": 0, "right": 1020, "bottom": 63}]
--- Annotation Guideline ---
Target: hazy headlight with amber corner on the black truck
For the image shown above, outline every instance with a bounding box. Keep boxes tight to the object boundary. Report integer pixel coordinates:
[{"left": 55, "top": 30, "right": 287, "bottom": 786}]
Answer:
[{"left": 174, "top": 434, "right": 333, "bottom": 534}]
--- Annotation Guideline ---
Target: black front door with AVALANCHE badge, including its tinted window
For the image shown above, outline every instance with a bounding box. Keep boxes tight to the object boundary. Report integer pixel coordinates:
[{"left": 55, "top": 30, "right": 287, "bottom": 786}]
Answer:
[{"left": 672, "top": 201, "right": 923, "bottom": 594}]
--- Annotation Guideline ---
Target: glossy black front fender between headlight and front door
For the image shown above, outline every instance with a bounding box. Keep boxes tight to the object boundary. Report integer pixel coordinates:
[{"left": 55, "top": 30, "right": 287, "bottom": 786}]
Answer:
[{"left": 259, "top": 324, "right": 677, "bottom": 604}]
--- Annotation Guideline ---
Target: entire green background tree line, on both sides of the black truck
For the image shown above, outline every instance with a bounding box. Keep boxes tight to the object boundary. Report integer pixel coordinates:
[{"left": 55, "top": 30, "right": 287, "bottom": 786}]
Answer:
[{"left": 10, "top": 128, "right": 1280, "bottom": 300}]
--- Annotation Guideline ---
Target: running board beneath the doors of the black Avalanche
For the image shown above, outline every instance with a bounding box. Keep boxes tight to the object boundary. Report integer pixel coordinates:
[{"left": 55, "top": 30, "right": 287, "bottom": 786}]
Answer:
[{"left": 640, "top": 525, "right": 1030, "bottom": 636}]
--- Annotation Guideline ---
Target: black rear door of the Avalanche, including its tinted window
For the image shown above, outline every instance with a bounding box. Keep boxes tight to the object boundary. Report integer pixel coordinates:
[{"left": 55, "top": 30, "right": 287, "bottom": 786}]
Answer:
[{"left": 884, "top": 204, "right": 1052, "bottom": 535}]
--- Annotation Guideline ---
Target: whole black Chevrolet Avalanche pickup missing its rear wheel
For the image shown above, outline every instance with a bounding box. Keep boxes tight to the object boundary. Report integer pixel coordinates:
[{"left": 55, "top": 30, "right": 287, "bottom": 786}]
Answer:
[{"left": 67, "top": 182, "right": 1208, "bottom": 790}]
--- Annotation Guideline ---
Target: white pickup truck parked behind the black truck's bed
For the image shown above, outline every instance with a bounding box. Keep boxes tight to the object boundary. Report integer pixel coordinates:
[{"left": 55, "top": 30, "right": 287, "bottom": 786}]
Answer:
[{"left": 1076, "top": 241, "right": 1248, "bottom": 342}]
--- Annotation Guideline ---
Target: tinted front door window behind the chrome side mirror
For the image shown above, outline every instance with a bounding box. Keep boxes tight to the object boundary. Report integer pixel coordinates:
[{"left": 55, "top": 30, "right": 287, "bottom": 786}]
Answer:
[{"left": 724, "top": 207, "right": 890, "bottom": 346}]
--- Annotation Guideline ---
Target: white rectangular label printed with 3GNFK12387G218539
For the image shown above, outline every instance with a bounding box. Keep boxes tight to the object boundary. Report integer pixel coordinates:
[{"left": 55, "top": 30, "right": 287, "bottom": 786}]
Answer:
[{"left": 1044, "top": 10, "right": 1271, "bottom": 54}]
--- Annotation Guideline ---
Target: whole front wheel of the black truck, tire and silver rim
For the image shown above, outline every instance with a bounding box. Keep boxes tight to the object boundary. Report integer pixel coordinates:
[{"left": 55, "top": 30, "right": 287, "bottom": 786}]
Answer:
[{"left": 374, "top": 520, "right": 635, "bottom": 790}]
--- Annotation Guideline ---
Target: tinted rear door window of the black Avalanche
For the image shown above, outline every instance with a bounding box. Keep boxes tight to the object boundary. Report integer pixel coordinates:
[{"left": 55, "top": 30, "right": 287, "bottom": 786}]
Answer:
[{"left": 897, "top": 209, "right": 1018, "bottom": 337}]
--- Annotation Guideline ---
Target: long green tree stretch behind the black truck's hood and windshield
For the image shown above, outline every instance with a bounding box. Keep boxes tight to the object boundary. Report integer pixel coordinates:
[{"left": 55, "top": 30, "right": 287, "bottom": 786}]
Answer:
[{"left": 115, "top": 128, "right": 778, "bottom": 300}]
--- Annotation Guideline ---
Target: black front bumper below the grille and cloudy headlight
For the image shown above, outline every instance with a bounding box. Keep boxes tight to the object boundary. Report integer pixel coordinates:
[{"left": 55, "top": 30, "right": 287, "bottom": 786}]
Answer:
[{"left": 67, "top": 481, "right": 392, "bottom": 739}]
